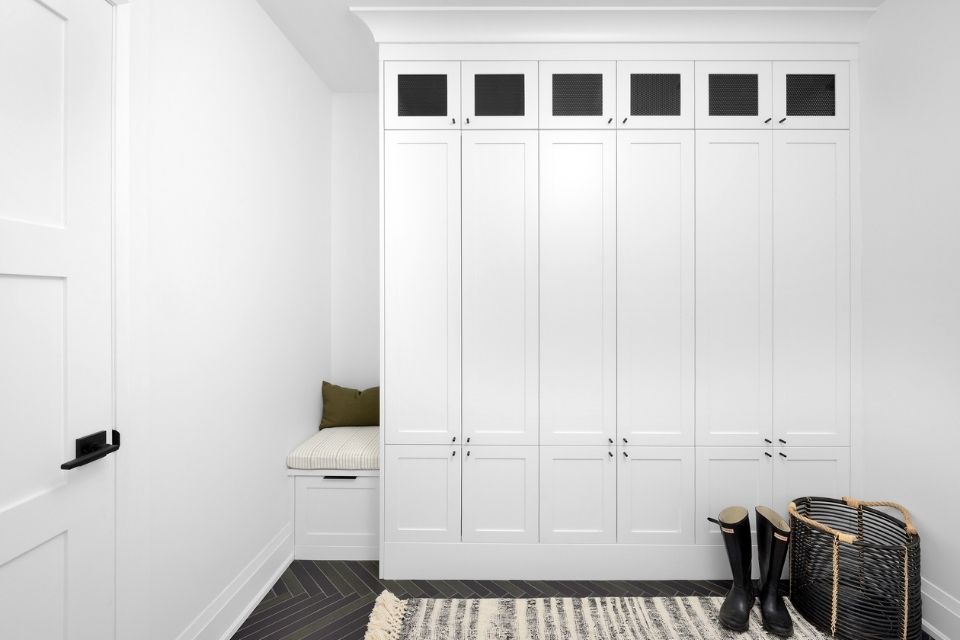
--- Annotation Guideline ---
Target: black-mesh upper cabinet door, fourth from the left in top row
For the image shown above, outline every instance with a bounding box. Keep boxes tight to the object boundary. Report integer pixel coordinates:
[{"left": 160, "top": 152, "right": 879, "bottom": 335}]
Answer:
[{"left": 617, "top": 62, "right": 694, "bottom": 129}]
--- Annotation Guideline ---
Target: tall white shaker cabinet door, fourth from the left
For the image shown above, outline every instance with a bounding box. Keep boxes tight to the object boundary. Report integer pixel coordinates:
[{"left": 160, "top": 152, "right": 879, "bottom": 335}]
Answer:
[{"left": 617, "top": 131, "right": 695, "bottom": 445}]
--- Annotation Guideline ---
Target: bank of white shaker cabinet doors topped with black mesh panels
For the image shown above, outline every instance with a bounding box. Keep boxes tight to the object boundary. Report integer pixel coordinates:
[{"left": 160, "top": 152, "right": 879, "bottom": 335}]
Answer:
[{"left": 382, "top": 60, "right": 855, "bottom": 577}]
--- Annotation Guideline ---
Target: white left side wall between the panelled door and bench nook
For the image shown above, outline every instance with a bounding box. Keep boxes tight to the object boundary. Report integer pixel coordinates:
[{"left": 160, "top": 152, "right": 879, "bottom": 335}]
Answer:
[{"left": 118, "top": 0, "right": 331, "bottom": 640}]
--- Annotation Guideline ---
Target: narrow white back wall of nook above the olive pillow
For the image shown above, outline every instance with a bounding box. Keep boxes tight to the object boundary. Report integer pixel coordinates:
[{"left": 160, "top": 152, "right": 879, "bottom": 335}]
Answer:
[{"left": 330, "top": 93, "right": 380, "bottom": 388}]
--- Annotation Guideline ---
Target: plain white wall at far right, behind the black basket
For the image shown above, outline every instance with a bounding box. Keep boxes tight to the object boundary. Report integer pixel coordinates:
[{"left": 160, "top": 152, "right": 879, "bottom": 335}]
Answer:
[{"left": 861, "top": 0, "right": 960, "bottom": 638}]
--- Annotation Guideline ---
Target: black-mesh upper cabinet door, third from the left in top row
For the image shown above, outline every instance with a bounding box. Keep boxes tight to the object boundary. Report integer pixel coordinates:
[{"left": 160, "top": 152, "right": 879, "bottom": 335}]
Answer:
[{"left": 540, "top": 61, "right": 616, "bottom": 129}]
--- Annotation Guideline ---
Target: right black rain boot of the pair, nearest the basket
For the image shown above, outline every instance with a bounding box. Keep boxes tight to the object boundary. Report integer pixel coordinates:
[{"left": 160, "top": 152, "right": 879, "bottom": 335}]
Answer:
[{"left": 757, "top": 507, "right": 793, "bottom": 638}]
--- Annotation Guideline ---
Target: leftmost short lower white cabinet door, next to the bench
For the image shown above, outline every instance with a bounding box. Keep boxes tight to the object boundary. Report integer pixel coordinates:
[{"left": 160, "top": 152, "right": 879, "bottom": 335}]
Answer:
[{"left": 383, "top": 445, "right": 461, "bottom": 542}]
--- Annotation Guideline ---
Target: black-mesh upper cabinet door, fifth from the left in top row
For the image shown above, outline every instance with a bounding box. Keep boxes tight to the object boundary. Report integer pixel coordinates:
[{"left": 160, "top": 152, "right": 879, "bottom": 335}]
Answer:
[{"left": 696, "top": 62, "right": 773, "bottom": 129}]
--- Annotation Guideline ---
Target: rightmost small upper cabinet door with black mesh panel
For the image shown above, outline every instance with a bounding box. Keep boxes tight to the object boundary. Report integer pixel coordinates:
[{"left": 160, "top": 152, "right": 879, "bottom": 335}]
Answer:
[{"left": 773, "top": 62, "right": 850, "bottom": 129}]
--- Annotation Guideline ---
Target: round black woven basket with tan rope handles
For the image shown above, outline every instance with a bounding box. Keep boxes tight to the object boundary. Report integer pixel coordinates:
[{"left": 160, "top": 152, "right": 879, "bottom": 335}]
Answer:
[{"left": 788, "top": 498, "right": 923, "bottom": 640}]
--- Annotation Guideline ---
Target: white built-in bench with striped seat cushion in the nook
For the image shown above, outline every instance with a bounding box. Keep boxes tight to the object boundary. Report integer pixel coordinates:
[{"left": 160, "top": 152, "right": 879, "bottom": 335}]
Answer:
[{"left": 287, "top": 427, "right": 380, "bottom": 560}]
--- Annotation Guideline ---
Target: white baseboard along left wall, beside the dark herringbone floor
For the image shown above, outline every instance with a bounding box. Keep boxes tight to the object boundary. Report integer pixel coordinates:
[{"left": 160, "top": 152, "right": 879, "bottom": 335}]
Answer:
[{"left": 177, "top": 524, "right": 293, "bottom": 640}]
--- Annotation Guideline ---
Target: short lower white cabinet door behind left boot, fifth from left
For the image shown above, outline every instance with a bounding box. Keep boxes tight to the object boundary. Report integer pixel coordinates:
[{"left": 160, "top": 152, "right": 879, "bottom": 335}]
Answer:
[{"left": 697, "top": 447, "right": 773, "bottom": 544}]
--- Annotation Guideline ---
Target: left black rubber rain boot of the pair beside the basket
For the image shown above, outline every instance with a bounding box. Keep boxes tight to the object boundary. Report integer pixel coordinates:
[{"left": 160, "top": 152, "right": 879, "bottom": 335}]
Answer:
[{"left": 708, "top": 507, "right": 754, "bottom": 632}]
